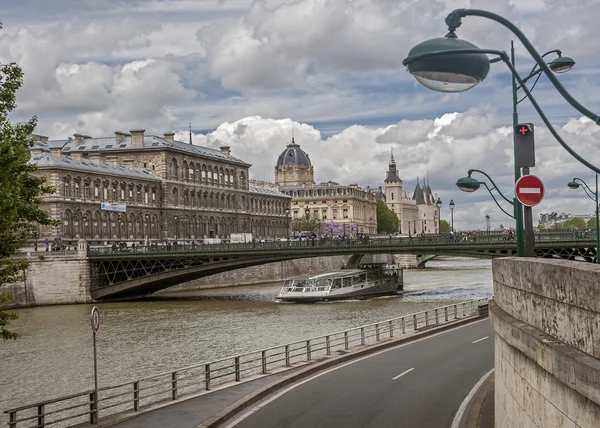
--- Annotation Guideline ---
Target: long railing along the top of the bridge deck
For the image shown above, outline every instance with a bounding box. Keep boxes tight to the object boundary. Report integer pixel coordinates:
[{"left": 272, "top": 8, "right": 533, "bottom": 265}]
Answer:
[{"left": 88, "top": 231, "right": 593, "bottom": 256}]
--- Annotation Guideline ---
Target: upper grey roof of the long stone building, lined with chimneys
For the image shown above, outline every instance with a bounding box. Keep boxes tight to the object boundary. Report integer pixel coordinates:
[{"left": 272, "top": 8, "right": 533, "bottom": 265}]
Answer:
[{"left": 38, "top": 134, "right": 250, "bottom": 167}]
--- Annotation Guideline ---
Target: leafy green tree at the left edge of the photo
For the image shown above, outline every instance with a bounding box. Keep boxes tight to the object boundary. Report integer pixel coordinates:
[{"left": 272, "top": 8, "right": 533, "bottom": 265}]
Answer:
[{"left": 0, "top": 61, "right": 56, "bottom": 340}]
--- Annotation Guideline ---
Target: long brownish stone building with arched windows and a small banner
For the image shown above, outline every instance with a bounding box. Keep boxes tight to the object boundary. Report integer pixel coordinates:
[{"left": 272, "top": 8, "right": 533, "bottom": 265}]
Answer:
[{"left": 31, "top": 129, "right": 291, "bottom": 243}]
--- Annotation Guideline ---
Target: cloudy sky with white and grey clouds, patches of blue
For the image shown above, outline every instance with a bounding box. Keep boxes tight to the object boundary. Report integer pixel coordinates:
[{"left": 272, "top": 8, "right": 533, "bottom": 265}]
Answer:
[{"left": 0, "top": 0, "right": 600, "bottom": 228}]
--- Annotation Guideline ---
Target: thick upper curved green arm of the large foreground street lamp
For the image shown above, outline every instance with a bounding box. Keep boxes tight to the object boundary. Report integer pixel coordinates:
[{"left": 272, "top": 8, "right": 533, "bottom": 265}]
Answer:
[{"left": 446, "top": 9, "right": 600, "bottom": 124}]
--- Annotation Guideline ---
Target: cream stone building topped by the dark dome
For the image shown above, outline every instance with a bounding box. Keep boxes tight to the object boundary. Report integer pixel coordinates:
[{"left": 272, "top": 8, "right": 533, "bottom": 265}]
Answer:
[{"left": 253, "top": 138, "right": 377, "bottom": 236}]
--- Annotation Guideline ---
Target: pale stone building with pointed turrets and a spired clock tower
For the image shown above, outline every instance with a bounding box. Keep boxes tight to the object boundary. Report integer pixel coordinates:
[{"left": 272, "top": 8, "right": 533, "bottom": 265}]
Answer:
[{"left": 377, "top": 152, "right": 440, "bottom": 235}]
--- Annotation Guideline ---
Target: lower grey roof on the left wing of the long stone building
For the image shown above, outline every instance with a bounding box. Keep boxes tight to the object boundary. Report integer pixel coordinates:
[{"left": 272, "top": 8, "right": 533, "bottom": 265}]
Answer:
[{"left": 30, "top": 151, "right": 160, "bottom": 182}]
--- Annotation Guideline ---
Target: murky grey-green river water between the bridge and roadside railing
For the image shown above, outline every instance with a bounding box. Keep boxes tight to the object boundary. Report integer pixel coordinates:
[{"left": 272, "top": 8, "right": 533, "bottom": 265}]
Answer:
[{"left": 0, "top": 258, "right": 492, "bottom": 419}]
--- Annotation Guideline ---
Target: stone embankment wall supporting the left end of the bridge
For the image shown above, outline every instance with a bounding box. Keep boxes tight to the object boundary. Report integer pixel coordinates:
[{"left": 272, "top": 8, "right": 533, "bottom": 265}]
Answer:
[{"left": 1, "top": 252, "right": 92, "bottom": 308}]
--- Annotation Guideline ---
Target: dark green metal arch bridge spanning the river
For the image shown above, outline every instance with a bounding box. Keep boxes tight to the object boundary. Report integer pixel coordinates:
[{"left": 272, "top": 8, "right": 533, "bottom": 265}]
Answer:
[{"left": 87, "top": 233, "right": 596, "bottom": 299}]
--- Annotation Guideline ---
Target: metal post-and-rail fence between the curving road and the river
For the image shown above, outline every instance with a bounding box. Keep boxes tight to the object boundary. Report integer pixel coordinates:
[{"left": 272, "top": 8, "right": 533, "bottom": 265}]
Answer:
[{"left": 4, "top": 299, "right": 487, "bottom": 428}]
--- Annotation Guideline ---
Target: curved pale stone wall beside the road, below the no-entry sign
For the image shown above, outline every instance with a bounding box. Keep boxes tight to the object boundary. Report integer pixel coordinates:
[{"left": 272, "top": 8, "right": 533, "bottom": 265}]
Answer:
[{"left": 490, "top": 258, "right": 600, "bottom": 428}]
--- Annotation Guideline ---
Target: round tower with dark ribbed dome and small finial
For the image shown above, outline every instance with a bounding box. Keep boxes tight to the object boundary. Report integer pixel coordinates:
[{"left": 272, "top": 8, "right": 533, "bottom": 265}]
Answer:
[{"left": 275, "top": 137, "right": 315, "bottom": 186}]
